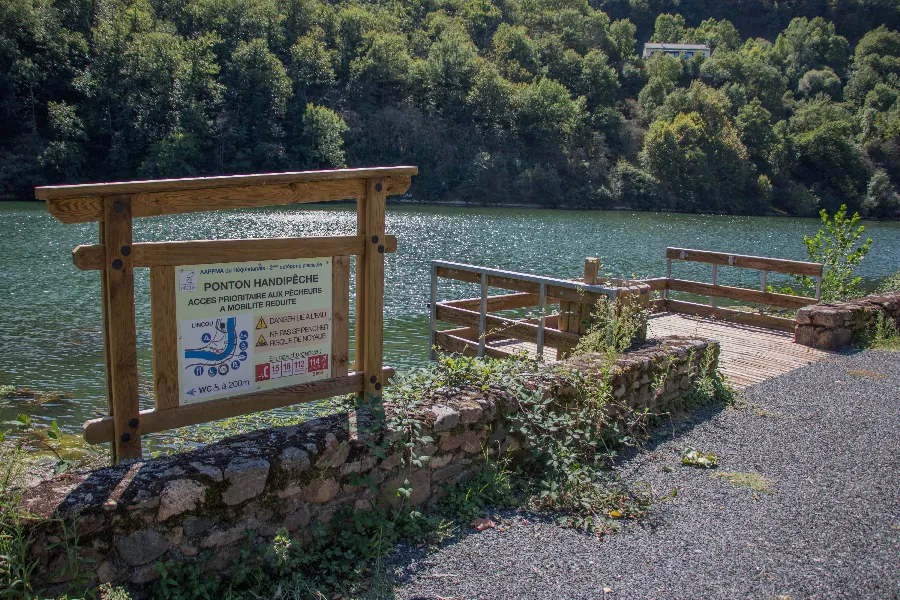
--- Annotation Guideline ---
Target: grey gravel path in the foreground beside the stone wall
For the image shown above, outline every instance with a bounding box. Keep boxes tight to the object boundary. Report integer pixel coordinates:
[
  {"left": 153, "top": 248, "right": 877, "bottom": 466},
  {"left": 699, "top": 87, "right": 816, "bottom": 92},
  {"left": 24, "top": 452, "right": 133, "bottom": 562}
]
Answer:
[{"left": 391, "top": 352, "right": 900, "bottom": 600}]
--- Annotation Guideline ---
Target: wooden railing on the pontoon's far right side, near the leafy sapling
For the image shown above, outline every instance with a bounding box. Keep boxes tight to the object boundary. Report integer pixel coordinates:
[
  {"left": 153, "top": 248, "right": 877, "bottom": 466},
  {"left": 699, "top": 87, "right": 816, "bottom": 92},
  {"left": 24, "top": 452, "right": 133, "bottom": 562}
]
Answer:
[{"left": 660, "top": 248, "right": 824, "bottom": 331}]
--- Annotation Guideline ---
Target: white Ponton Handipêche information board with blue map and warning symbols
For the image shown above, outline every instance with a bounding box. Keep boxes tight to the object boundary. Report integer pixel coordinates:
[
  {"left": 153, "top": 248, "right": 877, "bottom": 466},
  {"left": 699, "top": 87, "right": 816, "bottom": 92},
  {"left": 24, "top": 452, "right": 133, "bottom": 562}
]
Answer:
[{"left": 175, "top": 258, "right": 332, "bottom": 405}]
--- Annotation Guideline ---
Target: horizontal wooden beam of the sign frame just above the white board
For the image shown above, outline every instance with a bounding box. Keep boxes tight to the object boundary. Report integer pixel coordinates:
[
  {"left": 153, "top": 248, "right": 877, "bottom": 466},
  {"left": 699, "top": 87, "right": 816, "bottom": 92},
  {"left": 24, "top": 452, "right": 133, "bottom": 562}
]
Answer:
[{"left": 72, "top": 235, "right": 397, "bottom": 271}]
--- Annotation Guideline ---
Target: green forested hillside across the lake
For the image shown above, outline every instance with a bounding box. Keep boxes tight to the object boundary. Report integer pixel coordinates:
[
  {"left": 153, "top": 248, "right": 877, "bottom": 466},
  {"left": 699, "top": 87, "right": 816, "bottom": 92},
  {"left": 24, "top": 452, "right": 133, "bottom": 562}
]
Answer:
[{"left": 0, "top": 0, "right": 900, "bottom": 217}]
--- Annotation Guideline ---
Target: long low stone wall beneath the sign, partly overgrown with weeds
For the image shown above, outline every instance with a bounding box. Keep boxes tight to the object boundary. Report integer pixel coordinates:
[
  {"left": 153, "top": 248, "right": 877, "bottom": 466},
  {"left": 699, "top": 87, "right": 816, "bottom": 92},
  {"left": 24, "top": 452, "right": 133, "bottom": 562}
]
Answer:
[{"left": 23, "top": 338, "right": 718, "bottom": 592}]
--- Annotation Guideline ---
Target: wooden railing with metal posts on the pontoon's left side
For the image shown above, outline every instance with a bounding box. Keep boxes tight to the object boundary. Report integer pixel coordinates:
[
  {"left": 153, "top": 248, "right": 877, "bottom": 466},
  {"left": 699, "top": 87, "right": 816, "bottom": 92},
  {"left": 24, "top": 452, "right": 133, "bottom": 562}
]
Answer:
[{"left": 429, "top": 260, "right": 617, "bottom": 358}]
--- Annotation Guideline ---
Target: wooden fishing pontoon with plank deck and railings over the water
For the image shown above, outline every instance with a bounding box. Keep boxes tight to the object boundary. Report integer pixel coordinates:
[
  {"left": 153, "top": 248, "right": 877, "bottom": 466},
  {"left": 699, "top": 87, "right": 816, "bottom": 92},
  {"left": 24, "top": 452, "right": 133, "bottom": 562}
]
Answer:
[{"left": 430, "top": 248, "right": 831, "bottom": 389}]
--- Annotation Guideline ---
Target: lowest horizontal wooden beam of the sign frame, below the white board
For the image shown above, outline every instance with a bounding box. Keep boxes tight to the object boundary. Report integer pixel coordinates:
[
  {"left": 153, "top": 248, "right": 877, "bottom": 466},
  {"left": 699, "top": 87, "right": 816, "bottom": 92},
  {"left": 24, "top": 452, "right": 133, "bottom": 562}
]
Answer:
[{"left": 83, "top": 367, "right": 394, "bottom": 444}]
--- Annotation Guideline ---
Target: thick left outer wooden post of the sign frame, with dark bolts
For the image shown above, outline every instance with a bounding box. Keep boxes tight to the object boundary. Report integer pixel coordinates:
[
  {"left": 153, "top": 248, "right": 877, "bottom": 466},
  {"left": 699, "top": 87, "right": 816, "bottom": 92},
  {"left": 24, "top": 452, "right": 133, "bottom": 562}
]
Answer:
[{"left": 103, "top": 196, "right": 141, "bottom": 462}]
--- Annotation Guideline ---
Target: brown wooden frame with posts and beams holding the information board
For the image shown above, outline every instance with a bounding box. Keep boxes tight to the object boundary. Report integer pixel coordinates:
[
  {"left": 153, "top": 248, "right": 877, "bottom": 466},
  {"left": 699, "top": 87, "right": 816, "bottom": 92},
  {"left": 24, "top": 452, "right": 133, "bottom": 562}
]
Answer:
[{"left": 35, "top": 166, "right": 418, "bottom": 462}]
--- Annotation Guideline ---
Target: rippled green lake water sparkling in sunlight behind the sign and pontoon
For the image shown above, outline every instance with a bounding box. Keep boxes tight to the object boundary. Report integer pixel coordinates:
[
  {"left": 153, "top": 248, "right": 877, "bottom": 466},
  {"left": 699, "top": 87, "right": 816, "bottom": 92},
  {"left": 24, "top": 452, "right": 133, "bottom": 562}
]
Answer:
[{"left": 0, "top": 202, "right": 900, "bottom": 431}]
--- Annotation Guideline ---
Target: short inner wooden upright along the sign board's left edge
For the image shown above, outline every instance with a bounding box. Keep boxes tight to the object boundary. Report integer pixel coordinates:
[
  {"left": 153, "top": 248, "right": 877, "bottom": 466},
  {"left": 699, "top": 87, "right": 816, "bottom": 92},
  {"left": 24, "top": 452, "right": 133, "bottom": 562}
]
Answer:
[{"left": 150, "top": 267, "right": 179, "bottom": 410}]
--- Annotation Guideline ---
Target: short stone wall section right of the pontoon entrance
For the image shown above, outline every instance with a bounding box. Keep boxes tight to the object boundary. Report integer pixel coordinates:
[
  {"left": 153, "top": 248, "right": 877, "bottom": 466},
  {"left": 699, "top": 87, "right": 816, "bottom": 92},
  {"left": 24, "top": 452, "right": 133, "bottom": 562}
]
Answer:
[{"left": 794, "top": 292, "right": 900, "bottom": 350}]
